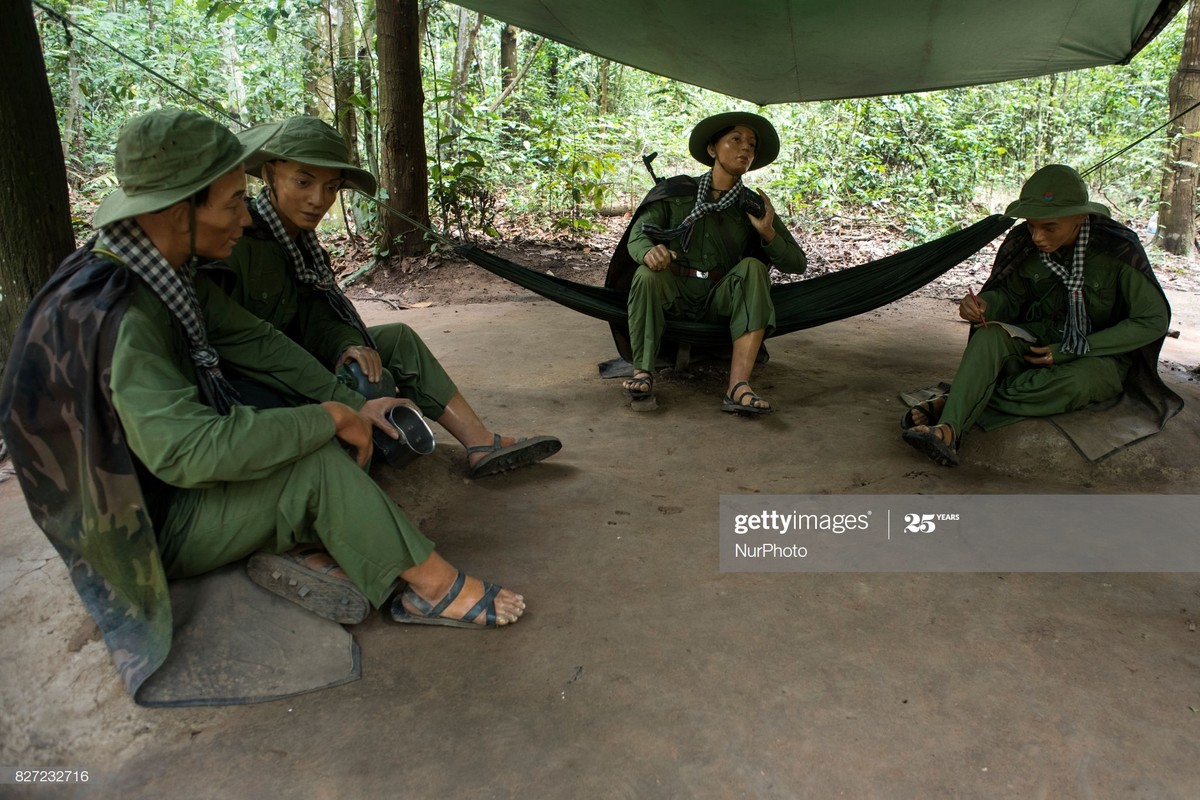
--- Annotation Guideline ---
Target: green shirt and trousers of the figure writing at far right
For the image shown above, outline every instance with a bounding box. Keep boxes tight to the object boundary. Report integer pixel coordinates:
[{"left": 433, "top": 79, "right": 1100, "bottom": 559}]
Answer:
[{"left": 938, "top": 245, "right": 1170, "bottom": 434}]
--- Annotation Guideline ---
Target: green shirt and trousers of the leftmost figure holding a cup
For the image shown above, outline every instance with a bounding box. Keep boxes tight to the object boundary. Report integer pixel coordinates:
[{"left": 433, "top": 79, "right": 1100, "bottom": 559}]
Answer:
[{"left": 109, "top": 268, "right": 433, "bottom": 606}]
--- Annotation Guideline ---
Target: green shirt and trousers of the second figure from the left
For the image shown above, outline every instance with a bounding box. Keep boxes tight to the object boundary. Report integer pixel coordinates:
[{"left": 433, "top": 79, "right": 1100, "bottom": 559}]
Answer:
[{"left": 217, "top": 214, "right": 458, "bottom": 420}]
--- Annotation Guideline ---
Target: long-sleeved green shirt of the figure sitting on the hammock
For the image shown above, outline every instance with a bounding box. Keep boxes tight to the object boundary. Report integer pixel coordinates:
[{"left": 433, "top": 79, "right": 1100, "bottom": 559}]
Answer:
[{"left": 629, "top": 183, "right": 809, "bottom": 273}]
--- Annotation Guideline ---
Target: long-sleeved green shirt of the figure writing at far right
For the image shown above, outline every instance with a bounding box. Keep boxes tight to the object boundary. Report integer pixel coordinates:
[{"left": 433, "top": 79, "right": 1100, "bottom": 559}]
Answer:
[{"left": 979, "top": 252, "right": 1170, "bottom": 363}]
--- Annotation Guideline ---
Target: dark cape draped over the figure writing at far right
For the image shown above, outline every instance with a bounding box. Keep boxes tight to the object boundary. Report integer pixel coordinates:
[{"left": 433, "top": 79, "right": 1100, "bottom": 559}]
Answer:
[{"left": 980, "top": 213, "right": 1183, "bottom": 429}]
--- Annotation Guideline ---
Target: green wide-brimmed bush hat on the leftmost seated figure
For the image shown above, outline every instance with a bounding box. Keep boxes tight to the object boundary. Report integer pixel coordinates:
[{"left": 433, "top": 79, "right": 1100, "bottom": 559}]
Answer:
[{"left": 92, "top": 108, "right": 277, "bottom": 228}]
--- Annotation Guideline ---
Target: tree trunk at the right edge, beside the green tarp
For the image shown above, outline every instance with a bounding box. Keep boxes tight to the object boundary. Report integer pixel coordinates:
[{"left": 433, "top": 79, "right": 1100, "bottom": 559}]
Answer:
[{"left": 1158, "top": 0, "right": 1200, "bottom": 255}]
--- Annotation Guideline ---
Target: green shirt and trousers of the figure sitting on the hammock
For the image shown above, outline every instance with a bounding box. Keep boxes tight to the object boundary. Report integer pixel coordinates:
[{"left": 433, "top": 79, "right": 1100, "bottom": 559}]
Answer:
[{"left": 628, "top": 179, "right": 808, "bottom": 371}]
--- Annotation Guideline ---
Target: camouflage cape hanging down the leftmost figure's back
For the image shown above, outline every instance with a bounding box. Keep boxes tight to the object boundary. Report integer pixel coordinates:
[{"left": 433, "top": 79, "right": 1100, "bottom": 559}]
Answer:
[{"left": 0, "top": 239, "right": 172, "bottom": 699}]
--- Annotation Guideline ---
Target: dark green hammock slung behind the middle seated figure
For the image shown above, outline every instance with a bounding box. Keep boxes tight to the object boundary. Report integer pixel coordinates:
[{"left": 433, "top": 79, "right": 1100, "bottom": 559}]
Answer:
[{"left": 455, "top": 213, "right": 1014, "bottom": 347}]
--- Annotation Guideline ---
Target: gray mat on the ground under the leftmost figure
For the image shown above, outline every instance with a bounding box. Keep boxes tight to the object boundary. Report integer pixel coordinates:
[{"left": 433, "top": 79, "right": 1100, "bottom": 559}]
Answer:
[{"left": 137, "top": 563, "right": 361, "bottom": 706}]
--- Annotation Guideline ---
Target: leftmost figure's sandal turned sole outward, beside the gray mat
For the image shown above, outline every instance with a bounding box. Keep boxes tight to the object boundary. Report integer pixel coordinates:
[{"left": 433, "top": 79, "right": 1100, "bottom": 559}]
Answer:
[{"left": 246, "top": 546, "right": 371, "bottom": 625}]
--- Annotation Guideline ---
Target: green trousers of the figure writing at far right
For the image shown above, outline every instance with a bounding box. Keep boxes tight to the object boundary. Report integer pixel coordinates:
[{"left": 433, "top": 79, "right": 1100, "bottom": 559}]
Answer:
[{"left": 940, "top": 325, "right": 1130, "bottom": 435}]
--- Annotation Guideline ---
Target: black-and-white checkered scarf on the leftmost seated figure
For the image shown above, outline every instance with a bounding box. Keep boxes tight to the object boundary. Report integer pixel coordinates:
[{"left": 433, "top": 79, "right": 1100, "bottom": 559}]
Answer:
[{"left": 92, "top": 219, "right": 240, "bottom": 415}]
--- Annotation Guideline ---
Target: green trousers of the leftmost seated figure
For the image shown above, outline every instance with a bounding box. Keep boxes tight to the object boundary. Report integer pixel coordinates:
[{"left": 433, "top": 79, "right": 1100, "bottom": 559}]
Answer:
[{"left": 157, "top": 440, "right": 433, "bottom": 607}]
